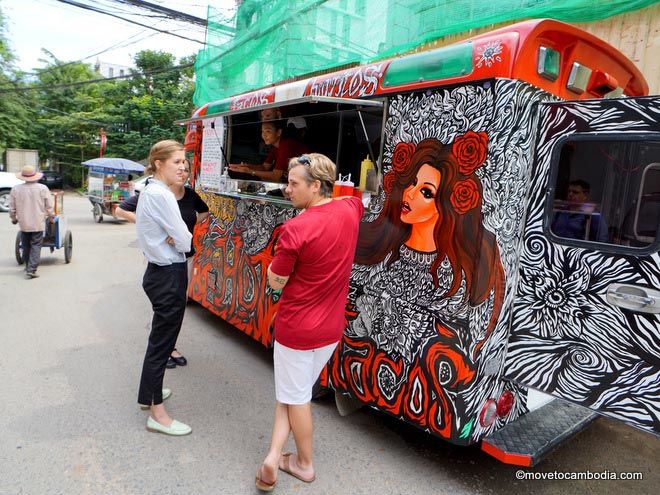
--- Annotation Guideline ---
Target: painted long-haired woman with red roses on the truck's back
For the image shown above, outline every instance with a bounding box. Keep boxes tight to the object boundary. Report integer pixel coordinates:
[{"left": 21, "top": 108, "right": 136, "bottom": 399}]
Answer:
[{"left": 348, "top": 131, "right": 504, "bottom": 364}]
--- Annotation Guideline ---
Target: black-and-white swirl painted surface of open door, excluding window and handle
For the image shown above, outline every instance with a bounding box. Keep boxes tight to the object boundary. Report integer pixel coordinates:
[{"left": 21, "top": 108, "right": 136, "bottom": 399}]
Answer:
[{"left": 505, "top": 97, "right": 660, "bottom": 433}]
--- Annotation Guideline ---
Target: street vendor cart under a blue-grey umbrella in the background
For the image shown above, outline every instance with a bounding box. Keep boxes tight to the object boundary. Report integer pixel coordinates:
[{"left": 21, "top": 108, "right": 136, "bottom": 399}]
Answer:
[{"left": 83, "top": 158, "right": 144, "bottom": 223}]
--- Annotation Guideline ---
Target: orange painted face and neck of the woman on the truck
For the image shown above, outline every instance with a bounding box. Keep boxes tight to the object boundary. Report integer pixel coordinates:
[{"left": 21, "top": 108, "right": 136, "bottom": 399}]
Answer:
[{"left": 401, "top": 164, "right": 440, "bottom": 224}]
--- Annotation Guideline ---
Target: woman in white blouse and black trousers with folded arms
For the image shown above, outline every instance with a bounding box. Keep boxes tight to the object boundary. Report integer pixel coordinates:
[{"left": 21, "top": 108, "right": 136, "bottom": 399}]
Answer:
[{"left": 135, "top": 140, "right": 192, "bottom": 435}]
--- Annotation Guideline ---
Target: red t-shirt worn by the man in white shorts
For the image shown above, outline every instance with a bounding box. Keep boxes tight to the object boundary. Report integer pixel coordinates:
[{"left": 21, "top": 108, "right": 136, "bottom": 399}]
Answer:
[{"left": 270, "top": 198, "right": 364, "bottom": 350}]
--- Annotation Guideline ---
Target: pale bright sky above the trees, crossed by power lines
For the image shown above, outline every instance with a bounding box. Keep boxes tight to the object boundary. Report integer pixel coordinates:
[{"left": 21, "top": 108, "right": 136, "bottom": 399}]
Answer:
[{"left": 0, "top": 0, "right": 220, "bottom": 72}]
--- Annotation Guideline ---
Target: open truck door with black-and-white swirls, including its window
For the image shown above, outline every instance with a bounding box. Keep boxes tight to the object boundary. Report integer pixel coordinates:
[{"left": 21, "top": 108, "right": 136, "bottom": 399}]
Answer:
[{"left": 505, "top": 96, "right": 660, "bottom": 435}]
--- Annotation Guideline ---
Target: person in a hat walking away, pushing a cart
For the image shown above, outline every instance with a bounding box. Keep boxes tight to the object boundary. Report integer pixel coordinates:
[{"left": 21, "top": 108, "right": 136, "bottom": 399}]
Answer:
[{"left": 9, "top": 165, "right": 55, "bottom": 279}]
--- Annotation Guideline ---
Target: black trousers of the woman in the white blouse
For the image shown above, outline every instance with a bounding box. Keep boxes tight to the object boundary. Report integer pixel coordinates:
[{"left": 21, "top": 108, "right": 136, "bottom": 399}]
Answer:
[{"left": 138, "top": 262, "right": 188, "bottom": 405}]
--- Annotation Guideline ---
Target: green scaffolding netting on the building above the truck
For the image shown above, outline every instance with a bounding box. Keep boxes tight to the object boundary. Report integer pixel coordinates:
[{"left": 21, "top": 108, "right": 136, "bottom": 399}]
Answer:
[{"left": 194, "top": 0, "right": 659, "bottom": 106}]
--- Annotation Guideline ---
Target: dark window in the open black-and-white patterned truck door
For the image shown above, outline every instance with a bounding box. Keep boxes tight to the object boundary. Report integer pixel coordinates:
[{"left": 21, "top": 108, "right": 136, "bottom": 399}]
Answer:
[{"left": 547, "top": 134, "right": 660, "bottom": 251}]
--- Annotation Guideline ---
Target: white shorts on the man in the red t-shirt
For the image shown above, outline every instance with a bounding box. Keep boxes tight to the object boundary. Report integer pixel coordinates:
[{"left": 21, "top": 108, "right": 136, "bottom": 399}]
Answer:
[{"left": 273, "top": 341, "right": 338, "bottom": 405}]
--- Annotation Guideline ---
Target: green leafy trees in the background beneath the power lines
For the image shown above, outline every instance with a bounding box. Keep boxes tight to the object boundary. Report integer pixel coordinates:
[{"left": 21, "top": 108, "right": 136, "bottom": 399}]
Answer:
[{"left": 0, "top": 12, "right": 194, "bottom": 186}]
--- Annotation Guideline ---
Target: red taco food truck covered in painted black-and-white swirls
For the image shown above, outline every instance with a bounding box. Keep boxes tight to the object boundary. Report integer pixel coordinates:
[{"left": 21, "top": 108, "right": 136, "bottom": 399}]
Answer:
[{"left": 181, "top": 20, "right": 660, "bottom": 466}]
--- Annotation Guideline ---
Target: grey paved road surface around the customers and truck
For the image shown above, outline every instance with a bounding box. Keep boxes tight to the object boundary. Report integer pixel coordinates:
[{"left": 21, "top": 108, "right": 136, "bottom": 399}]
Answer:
[{"left": 0, "top": 194, "right": 660, "bottom": 495}]
